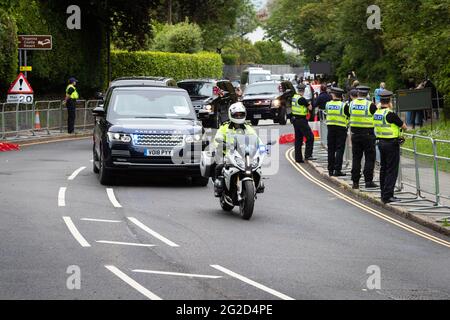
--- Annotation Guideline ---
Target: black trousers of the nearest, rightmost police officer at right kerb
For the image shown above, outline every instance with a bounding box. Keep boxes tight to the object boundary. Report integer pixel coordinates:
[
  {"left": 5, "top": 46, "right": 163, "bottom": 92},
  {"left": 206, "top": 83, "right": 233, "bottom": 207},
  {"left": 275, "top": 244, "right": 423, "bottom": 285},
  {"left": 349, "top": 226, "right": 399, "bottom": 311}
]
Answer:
[{"left": 378, "top": 139, "right": 400, "bottom": 201}]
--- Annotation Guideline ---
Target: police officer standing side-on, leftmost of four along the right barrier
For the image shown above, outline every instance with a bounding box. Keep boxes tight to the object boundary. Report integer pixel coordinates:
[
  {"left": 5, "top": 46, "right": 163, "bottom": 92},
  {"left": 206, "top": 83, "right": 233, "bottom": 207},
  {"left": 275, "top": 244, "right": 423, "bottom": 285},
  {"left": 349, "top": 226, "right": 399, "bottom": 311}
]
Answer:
[{"left": 291, "top": 84, "right": 316, "bottom": 163}]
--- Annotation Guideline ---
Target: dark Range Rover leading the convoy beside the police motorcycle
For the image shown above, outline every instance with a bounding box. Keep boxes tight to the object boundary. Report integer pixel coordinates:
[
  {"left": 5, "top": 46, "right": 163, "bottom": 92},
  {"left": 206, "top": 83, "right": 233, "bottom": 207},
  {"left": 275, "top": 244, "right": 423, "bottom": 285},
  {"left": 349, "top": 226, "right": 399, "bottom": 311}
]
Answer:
[{"left": 93, "top": 78, "right": 208, "bottom": 186}]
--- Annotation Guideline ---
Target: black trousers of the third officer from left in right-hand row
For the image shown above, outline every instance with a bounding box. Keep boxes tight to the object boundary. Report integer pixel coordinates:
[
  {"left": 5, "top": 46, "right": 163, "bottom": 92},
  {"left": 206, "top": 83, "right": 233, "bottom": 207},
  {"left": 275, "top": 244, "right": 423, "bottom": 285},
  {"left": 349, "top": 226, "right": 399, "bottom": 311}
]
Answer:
[{"left": 352, "top": 130, "right": 377, "bottom": 183}]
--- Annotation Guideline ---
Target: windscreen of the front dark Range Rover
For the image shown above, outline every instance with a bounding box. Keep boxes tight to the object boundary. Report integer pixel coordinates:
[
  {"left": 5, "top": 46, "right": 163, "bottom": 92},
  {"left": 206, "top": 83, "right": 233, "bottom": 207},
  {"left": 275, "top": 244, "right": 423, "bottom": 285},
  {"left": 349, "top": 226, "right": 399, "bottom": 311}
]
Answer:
[{"left": 108, "top": 89, "right": 196, "bottom": 120}]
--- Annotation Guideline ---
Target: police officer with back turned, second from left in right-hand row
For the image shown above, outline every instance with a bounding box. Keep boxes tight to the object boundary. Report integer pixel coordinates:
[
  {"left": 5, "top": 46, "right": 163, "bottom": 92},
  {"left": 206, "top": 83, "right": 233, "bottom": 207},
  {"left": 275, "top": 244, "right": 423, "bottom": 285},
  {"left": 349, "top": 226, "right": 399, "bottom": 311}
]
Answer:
[{"left": 325, "top": 87, "right": 348, "bottom": 177}]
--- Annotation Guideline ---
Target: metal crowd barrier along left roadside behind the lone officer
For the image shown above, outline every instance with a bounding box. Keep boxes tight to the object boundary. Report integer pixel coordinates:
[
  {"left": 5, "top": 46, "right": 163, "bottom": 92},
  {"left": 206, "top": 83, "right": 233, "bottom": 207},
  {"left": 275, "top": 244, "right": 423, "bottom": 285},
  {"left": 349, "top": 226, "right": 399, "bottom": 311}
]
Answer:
[{"left": 0, "top": 100, "right": 100, "bottom": 139}]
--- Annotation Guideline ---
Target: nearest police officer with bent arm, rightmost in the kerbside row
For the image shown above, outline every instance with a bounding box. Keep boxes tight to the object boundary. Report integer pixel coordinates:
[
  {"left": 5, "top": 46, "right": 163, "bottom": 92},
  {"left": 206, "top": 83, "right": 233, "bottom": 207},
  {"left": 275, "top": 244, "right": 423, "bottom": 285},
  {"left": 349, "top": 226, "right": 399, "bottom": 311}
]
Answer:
[{"left": 374, "top": 90, "right": 406, "bottom": 203}]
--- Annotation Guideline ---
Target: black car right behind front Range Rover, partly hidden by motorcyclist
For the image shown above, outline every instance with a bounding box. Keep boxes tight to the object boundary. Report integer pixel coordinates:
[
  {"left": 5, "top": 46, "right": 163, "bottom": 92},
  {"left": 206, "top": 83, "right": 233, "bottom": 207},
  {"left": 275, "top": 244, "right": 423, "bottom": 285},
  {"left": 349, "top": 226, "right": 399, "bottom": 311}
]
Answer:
[{"left": 178, "top": 79, "right": 238, "bottom": 129}]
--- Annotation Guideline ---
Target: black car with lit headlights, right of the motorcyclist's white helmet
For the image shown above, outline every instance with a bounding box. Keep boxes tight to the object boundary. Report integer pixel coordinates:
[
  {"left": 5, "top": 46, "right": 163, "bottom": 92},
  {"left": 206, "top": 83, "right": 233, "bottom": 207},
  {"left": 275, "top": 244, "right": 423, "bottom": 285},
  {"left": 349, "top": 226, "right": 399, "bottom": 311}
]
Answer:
[{"left": 242, "top": 81, "right": 295, "bottom": 125}]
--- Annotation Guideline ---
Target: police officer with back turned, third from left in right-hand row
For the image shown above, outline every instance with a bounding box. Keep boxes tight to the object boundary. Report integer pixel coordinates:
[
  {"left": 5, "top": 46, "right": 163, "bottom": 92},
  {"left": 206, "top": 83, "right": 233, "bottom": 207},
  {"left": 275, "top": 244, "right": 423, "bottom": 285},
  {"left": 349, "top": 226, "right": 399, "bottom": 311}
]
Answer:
[{"left": 345, "top": 86, "right": 378, "bottom": 189}]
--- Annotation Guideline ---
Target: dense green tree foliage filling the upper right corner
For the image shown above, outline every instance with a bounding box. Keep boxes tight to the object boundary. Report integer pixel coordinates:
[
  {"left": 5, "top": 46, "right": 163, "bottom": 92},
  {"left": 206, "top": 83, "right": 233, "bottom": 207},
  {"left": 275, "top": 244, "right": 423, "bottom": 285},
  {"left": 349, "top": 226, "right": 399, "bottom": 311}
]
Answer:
[{"left": 266, "top": 0, "right": 450, "bottom": 117}]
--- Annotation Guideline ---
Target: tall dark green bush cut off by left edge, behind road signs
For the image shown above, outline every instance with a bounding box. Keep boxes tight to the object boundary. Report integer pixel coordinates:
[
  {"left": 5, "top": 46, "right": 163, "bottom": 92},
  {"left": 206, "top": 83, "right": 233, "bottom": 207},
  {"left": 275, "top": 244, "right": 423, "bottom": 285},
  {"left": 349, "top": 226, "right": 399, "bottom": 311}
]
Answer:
[{"left": 0, "top": 9, "right": 17, "bottom": 93}]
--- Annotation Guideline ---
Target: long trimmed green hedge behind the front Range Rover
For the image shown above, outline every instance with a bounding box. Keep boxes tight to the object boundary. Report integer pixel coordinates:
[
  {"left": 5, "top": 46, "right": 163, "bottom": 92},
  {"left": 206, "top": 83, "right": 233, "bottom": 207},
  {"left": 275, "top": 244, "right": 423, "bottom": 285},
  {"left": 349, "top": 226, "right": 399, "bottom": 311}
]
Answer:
[{"left": 111, "top": 51, "right": 223, "bottom": 80}]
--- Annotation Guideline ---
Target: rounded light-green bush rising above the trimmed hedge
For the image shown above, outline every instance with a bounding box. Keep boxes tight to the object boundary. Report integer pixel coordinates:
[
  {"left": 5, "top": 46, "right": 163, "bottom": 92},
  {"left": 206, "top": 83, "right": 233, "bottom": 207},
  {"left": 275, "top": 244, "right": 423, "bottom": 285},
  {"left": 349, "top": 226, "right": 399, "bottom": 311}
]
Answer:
[{"left": 153, "top": 21, "right": 203, "bottom": 53}]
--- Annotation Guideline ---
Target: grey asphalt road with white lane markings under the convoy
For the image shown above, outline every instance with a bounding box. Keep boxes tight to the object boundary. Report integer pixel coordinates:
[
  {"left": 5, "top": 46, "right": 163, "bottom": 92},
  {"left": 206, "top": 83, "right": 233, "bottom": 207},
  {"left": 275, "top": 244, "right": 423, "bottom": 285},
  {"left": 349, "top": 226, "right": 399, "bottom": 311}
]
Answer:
[{"left": 0, "top": 122, "right": 450, "bottom": 300}]
